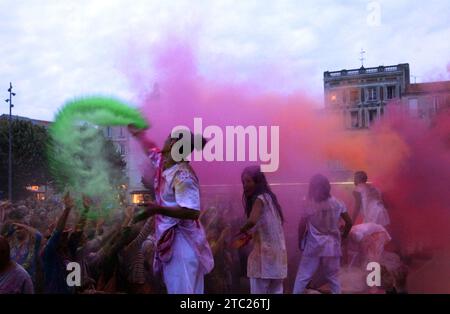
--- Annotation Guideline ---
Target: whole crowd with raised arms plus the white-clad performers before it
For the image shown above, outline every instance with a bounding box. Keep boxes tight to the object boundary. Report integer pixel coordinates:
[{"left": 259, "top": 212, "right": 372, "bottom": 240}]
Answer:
[{"left": 0, "top": 126, "right": 405, "bottom": 294}]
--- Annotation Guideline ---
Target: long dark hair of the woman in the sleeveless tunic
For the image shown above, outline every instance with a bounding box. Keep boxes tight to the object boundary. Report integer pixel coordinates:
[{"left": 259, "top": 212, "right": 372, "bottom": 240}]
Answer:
[{"left": 241, "top": 166, "right": 284, "bottom": 222}]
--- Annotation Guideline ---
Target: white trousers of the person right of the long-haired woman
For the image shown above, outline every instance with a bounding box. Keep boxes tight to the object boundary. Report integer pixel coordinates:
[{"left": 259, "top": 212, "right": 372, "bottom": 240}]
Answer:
[{"left": 292, "top": 256, "right": 341, "bottom": 293}]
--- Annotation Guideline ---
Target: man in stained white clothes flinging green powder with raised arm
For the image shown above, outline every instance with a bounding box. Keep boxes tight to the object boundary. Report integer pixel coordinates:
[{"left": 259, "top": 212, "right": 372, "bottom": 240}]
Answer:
[{"left": 130, "top": 127, "right": 214, "bottom": 294}]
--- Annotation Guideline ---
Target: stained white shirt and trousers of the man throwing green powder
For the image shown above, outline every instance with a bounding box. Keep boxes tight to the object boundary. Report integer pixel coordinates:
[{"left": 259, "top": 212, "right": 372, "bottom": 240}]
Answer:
[{"left": 155, "top": 157, "right": 214, "bottom": 294}]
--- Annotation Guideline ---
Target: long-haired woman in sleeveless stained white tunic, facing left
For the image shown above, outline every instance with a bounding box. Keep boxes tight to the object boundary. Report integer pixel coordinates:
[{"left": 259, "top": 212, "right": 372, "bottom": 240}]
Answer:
[{"left": 240, "top": 166, "right": 287, "bottom": 294}]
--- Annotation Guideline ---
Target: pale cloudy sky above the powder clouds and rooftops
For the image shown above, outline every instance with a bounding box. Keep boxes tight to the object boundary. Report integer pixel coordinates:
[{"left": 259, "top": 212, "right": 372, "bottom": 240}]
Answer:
[{"left": 0, "top": 0, "right": 450, "bottom": 120}]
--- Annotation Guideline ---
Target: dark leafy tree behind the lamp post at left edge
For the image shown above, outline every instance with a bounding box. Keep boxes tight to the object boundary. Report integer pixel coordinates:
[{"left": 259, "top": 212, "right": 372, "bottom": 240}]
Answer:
[{"left": 0, "top": 119, "right": 49, "bottom": 200}]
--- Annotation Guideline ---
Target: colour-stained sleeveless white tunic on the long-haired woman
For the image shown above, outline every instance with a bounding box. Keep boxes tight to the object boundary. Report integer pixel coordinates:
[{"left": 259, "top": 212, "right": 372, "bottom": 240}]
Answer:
[{"left": 247, "top": 193, "right": 287, "bottom": 279}]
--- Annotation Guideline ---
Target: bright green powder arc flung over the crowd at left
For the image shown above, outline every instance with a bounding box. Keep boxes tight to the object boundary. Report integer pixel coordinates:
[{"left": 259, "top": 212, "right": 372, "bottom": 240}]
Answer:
[{"left": 47, "top": 96, "right": 149, "bottom": 218}]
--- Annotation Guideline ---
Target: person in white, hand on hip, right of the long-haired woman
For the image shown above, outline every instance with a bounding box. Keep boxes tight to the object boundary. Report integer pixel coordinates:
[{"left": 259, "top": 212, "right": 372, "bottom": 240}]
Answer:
[{"left": 293, "top": 174, "right": 352, "bottom": 294}]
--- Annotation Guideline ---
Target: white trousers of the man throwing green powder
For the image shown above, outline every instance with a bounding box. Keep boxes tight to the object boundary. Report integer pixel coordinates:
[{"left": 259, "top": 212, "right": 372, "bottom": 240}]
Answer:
[{"left": 163, "top": 232, "right": 204, "bottom": 294}]
